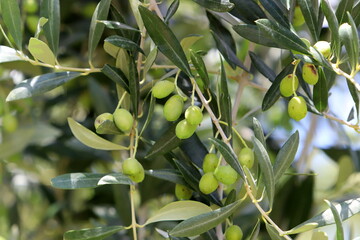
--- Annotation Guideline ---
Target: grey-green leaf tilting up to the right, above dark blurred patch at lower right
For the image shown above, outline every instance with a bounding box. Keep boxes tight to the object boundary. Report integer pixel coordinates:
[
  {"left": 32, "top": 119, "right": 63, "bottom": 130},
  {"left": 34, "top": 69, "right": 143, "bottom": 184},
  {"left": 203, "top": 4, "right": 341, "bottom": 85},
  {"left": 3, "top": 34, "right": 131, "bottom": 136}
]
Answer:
[{"left": 274, "top": 131, "right": 299, "bottom": 183}]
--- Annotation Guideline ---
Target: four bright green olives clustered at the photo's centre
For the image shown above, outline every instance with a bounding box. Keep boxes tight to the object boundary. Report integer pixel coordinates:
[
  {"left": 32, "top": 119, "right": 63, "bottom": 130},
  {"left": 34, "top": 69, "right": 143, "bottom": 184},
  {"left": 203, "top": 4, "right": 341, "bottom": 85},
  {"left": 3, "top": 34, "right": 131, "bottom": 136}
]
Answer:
[{"left": 152, "top": 80, "right": 203, "bottom": 139}]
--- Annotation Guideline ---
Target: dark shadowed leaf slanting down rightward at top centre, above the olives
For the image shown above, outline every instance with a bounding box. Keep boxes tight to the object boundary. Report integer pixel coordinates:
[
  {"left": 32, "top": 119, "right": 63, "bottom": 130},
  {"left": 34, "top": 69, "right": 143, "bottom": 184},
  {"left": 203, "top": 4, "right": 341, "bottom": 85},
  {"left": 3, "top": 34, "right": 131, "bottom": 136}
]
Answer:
[{"left": 206, "top": 12, "right": 248, "bottom": 71}]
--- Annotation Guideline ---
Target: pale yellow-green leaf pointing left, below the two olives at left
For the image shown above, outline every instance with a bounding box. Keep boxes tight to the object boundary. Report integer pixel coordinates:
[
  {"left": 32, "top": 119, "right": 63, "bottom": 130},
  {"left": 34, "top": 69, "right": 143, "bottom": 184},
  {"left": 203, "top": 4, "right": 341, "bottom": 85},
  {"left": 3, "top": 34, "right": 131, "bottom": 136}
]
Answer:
[{"left": 68, "top": 118, "right": 127, "bottom": 150}]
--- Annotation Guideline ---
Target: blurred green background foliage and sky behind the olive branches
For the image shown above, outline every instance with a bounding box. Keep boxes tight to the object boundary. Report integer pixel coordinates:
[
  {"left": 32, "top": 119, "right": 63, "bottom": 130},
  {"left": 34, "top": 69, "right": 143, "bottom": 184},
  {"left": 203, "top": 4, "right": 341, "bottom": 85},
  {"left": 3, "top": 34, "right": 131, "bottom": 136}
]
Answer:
[{"left": 0, "top": 0, "right": 360, "bottom": 240}]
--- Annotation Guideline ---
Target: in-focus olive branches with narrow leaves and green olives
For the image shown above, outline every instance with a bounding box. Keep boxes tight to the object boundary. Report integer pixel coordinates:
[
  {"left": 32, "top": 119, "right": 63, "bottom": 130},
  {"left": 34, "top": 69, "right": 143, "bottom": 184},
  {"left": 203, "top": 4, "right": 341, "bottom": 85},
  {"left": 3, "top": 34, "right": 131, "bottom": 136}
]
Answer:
[{"left": 0, "top": 0, "right": 360, "bottom": 240}]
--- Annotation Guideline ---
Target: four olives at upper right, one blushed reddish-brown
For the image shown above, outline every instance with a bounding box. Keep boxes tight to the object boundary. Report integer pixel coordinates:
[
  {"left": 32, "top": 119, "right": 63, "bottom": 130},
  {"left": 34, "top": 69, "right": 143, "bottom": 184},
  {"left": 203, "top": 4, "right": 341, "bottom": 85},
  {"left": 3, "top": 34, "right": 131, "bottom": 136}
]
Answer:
[{"left": 280, "top": 39, "right": 331, "bottom": 121}]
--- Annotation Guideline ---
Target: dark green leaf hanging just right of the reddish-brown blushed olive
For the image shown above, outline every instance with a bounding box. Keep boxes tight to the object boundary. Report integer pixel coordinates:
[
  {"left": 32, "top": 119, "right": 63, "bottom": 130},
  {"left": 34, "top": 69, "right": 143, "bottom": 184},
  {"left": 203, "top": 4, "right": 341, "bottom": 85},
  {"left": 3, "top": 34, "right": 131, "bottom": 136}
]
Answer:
[{"left": 313, "top": 67, "right": 329, "bottom": 112}]
